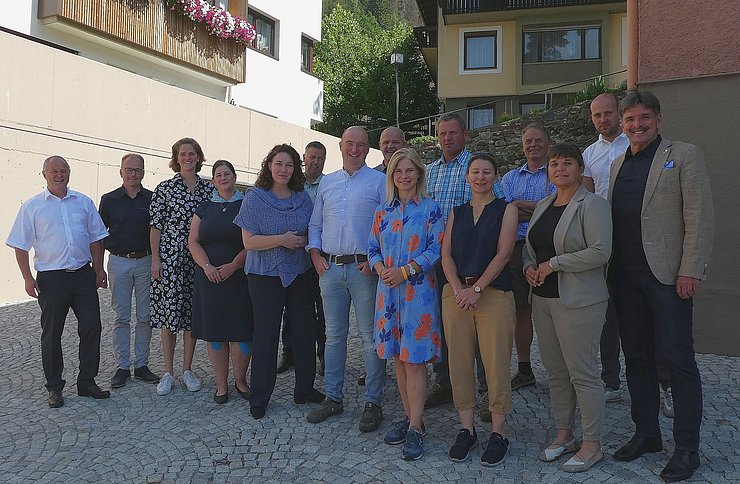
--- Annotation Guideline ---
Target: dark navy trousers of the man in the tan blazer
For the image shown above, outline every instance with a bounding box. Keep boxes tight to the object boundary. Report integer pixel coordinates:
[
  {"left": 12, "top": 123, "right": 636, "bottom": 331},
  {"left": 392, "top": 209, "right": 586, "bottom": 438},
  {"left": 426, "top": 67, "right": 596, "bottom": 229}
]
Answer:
[{"left": 611, "top": 267, "right": 702, "bottom": 452}]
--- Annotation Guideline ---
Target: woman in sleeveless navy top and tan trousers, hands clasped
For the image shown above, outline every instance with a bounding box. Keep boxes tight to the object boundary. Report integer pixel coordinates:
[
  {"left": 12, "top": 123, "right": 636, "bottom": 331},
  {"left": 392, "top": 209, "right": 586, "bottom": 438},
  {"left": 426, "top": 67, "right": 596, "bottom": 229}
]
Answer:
[{"left": 442, "top": 153, "right": 518, "bottom": 466}]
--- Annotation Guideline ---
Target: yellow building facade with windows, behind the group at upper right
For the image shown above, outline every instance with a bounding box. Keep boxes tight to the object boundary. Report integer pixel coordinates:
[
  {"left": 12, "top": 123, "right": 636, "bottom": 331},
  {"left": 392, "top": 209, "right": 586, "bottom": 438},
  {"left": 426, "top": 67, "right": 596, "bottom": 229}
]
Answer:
[{"left": 416, "top": 0, "right": 627, "bottom": 128}]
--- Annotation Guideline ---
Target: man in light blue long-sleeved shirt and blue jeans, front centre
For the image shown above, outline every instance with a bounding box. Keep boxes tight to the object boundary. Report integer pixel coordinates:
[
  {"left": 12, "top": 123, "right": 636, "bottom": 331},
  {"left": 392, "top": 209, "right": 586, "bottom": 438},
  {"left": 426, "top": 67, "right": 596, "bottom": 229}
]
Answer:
[{"left": 306, "top": 126, "right": 385, "bottom": 432}]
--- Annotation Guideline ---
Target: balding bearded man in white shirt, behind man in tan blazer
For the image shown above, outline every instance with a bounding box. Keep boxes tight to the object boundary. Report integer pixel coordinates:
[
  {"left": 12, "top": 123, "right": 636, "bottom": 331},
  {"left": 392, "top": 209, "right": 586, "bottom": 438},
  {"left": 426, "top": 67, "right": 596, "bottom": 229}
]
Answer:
[{"left": 583, "top": 94, "right": 630, "bottom": 402}]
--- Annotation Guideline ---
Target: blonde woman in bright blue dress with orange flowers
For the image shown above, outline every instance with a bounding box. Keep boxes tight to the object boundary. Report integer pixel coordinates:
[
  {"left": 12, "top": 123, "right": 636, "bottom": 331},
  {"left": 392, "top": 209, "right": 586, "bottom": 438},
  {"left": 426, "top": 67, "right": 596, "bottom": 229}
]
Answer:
[{"left": 368, "top": 148, "right": 444, "bottom": 460}]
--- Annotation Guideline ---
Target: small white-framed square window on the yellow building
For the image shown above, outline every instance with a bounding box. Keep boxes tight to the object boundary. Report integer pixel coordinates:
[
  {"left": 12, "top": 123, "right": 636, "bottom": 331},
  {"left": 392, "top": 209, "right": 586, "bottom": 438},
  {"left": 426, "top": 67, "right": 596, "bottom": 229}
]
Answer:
[{"left": 460, "top": 27, "right": 501, "bottom": 74}]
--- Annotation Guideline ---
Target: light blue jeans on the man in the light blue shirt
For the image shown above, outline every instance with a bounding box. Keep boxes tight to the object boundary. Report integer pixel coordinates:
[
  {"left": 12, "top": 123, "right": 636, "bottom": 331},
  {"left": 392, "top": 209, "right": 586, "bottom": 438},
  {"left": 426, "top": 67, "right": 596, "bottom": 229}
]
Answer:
[{"left": 319, "top": 264, "right": 385, "bottom": 405}]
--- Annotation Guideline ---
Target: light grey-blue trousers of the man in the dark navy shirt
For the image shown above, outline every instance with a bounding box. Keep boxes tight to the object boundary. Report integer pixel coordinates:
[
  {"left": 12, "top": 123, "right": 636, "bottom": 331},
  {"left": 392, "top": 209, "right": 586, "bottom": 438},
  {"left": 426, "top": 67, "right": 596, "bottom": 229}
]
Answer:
[{"left": 108, "top": 255, "right": 152, "bottom": 370}]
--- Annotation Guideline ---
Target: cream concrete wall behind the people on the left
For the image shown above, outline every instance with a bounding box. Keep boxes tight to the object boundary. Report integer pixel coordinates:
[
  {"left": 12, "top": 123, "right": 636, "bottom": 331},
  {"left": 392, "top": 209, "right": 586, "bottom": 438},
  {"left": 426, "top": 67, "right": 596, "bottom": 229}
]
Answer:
[{"left": 0, "top": 32, "right": 372, "bottom": 303}]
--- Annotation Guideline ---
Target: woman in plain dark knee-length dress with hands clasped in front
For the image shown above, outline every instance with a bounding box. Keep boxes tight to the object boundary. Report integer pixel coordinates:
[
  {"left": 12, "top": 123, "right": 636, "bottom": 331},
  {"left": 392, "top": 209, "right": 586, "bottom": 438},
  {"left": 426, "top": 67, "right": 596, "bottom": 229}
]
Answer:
[{"left": 188, "top": 160, "right": 254, "bottom": 404}]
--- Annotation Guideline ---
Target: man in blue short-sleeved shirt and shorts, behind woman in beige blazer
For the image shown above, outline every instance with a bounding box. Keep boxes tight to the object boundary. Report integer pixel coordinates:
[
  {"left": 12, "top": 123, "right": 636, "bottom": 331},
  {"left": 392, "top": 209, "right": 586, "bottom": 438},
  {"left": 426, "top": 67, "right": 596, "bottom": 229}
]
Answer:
[{"left": 502, "top": 124, "right": 554, "bottom": 390}]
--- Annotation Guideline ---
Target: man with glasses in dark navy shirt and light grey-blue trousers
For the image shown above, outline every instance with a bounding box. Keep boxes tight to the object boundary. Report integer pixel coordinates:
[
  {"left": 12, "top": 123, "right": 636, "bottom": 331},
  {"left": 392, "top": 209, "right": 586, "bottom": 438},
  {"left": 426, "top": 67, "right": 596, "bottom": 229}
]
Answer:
[{"left": 99, "top": 153, "right": 159, "bottom": 388}]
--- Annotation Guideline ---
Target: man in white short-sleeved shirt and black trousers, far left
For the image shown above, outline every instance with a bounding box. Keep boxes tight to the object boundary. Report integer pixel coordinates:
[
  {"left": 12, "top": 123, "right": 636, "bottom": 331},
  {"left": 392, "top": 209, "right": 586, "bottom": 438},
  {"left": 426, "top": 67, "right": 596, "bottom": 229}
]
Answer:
[{"left": 5, "top": 156, "right": 110, "bottom": 408}]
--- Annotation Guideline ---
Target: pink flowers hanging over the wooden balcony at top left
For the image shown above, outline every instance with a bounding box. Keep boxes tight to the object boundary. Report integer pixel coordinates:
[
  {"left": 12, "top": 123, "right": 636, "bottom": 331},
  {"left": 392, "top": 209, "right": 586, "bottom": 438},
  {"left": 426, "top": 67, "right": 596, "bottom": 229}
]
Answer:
[{"left": 164, "top": 0, "right": 257, "bottom": 44}]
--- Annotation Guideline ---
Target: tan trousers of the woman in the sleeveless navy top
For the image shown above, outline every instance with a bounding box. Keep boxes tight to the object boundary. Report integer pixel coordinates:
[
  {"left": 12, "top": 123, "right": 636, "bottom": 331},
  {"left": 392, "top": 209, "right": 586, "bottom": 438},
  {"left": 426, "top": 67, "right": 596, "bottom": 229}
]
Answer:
[{"left": 442, "top": 284, "right": 515, "bottom": 415}]
